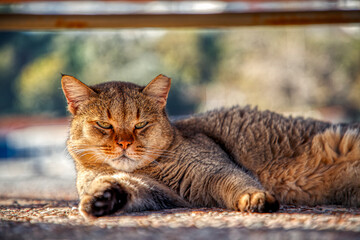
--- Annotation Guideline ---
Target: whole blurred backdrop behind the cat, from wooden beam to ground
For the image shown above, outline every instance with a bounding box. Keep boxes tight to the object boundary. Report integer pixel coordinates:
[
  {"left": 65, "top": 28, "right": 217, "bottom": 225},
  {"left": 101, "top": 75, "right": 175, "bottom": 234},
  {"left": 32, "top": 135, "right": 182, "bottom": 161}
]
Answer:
[{"left": 0, "top": 0, "right": 360, "bottom": 198}]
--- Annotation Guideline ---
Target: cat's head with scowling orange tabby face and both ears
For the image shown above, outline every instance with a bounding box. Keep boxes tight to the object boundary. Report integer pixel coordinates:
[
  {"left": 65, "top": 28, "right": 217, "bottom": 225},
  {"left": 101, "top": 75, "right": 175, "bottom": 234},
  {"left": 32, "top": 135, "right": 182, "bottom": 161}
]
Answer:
[{"left": 61, "top": 75, "right": 173, "bottom": 172}]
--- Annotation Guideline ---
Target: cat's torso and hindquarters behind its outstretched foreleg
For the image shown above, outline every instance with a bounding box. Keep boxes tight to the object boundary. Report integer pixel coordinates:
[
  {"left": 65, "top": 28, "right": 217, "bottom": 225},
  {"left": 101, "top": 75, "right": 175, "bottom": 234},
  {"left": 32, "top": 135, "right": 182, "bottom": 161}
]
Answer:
[{"left": 176, "top": 107, "right": 360, "bottom": 206}]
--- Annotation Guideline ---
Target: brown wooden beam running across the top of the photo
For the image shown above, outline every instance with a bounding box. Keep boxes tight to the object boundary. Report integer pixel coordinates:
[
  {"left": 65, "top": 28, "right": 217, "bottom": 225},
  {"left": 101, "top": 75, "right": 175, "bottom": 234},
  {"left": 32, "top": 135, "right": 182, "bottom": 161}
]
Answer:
[{"left": 0, "top": 10, "right": 360, "bottom": 30}]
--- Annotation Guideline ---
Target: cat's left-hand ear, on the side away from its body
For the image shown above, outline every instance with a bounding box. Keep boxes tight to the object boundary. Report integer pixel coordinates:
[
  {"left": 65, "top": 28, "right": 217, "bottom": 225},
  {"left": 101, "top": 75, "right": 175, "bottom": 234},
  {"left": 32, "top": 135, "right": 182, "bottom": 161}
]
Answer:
[{"left": 61, "top": 75, "right": 95, "bottom": 115}]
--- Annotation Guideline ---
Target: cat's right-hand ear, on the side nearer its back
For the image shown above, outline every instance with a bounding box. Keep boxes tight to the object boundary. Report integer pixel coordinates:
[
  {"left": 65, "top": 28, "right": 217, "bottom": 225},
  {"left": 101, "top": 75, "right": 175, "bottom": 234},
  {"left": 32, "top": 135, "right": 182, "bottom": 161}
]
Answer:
[{"left": 143, "top": 74, "right": 171, "bottom": 107}]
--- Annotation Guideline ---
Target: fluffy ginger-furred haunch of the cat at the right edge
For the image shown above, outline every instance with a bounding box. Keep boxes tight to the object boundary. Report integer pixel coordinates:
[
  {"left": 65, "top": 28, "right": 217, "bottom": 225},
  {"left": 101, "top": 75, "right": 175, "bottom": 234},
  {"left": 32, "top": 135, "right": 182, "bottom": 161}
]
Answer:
[{"left": 312, "top": 127, "right": 360, "bottom": 207}]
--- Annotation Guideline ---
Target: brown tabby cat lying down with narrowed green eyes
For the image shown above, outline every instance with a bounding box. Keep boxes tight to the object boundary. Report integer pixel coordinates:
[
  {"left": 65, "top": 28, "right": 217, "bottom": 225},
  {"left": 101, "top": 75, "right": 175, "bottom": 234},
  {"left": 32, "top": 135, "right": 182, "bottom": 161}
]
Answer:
[{"left": 62, "top": 75, "right": 360, "bottom": 218}]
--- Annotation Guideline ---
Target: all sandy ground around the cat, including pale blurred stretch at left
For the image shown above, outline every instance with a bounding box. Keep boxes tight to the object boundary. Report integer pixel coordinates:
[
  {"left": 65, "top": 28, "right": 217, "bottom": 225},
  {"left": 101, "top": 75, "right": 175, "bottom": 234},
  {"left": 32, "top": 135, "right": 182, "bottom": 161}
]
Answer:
[{"left": 0, "top": 159, "right": 360, "bottom": 240}]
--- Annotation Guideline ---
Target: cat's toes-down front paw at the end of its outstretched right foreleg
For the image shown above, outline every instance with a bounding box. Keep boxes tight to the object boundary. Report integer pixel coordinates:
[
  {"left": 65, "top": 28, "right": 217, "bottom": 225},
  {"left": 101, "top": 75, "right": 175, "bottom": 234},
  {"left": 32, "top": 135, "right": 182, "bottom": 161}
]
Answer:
[{"left": 238, "top": 191, "right": 279, "bottom": 212}]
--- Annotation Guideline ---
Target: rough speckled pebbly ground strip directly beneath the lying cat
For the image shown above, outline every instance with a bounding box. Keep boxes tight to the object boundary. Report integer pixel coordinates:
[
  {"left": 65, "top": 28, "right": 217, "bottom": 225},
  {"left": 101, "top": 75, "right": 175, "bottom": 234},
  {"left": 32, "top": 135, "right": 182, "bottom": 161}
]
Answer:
[{"left": 0, "top": 198, "right": 360, "bottom": 240}]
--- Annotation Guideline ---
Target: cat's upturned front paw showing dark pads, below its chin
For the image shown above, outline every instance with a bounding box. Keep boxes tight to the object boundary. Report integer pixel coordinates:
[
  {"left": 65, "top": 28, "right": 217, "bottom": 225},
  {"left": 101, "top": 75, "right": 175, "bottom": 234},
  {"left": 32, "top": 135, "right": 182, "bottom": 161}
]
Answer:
[{"left": 79, "top": 178, "right": 128, "bottom": 219}]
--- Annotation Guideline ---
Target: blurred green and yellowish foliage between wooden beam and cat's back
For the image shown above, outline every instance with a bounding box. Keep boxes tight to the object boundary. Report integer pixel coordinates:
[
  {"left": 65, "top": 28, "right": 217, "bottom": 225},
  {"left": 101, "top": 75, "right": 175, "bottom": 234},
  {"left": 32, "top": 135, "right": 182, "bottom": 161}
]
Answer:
[{"left": 0, "top": 26, "right": 360, "bottom": 121}]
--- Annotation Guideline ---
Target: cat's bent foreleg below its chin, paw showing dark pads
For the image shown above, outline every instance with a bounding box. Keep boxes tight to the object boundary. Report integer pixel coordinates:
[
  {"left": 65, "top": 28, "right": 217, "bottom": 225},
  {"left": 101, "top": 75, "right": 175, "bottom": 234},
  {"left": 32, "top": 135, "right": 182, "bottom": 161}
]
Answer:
[{"left": 79, "top": 172, "right": 189, "bottom": 219}]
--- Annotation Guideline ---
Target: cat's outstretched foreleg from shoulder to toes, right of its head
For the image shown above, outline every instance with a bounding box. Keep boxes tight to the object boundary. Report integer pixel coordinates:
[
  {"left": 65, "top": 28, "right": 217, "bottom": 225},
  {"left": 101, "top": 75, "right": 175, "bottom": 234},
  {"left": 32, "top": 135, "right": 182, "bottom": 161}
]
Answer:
[{"left": 175, "top": 134, "right": 279, "bottom": 212}]
